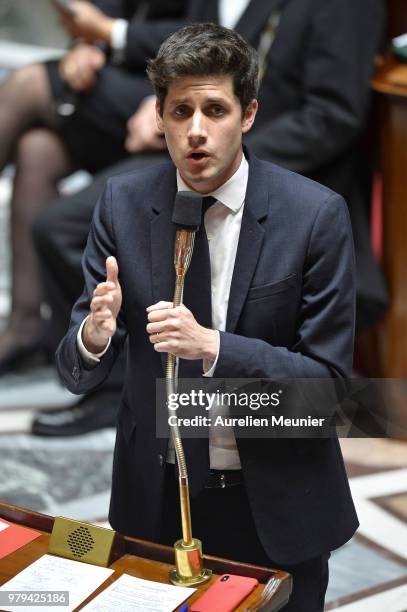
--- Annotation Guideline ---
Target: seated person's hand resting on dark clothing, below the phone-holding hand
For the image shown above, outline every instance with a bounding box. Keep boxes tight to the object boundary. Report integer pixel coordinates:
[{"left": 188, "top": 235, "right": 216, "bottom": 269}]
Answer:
[{"left": 59, "top": 44, "right": 106, "bottom": 92}]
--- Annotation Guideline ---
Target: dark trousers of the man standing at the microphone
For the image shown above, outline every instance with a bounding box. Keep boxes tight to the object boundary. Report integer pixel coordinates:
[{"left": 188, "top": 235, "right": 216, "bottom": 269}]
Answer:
[{"left": 160, "top": 466, "right": 330, "bottom": 612}]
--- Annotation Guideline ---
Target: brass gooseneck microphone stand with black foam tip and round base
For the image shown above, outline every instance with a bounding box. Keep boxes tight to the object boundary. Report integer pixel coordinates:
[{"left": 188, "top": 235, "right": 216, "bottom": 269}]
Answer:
[{"left": 166, "top": 191, "right": 212, "bottom": 586}]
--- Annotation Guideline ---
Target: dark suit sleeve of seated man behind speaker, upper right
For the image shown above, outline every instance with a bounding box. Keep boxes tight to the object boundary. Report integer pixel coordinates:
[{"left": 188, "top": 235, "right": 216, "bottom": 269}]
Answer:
[{"left": 246, "top": 0, "right": 384, "bottom": 175}]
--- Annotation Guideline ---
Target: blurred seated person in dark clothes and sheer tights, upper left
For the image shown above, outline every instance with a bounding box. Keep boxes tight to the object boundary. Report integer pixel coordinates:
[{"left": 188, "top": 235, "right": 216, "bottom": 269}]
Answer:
[{"left": 0, "top": 0, "right": 185, "bottom": 373}]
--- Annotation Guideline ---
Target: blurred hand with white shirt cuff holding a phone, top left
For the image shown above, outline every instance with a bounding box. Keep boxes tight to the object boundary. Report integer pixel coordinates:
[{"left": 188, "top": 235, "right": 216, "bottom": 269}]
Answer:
[{"left": 55, "top": 0, "right": 115, "bottom": 45}]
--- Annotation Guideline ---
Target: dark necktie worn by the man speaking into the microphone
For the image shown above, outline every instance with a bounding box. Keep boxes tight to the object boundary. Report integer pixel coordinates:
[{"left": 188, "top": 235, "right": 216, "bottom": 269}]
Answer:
[{"left": 178, "top": 196, "right": 216, "bottom": 496}]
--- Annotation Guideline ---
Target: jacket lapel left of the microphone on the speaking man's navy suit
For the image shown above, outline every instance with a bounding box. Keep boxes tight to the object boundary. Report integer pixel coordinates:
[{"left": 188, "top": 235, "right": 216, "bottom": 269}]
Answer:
[{"left": 150, "top": 168, "right": 177, "bottom": 369}]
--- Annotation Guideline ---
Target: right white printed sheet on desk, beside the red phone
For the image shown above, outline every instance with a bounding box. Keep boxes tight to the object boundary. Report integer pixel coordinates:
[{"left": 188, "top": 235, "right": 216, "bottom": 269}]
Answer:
[{"left": 81, "top": 574, "right": 196, "bottom": 612}]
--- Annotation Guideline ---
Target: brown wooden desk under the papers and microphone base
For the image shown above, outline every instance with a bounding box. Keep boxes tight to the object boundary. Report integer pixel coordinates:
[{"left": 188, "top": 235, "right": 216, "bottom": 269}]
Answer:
[{"left": 0, "top": 503, "right": 292, "bottom": 612}]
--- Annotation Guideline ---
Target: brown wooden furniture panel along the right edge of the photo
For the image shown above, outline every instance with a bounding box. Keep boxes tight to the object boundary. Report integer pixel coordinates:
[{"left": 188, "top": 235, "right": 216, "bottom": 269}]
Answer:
[{"left": 372, "top": 57, "right": 407, "bottom": 378}]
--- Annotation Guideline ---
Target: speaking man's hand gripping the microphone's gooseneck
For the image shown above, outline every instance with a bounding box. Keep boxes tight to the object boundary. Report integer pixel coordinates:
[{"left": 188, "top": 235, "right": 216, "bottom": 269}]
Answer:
[{"left": 147, "top": 302, "right": 218, "bottom": 361}]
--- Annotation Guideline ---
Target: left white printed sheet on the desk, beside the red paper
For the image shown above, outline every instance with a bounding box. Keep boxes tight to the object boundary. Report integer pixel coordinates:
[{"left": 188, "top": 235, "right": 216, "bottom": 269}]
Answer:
[{"left": 0, "top": 555, "right": 114, "bottom": 612}]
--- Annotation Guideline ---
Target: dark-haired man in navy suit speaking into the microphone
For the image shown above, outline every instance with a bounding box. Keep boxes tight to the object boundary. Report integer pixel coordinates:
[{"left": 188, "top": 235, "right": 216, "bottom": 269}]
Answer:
[{"left": 57, "top": 24, "right": 357, "bottom": 612}]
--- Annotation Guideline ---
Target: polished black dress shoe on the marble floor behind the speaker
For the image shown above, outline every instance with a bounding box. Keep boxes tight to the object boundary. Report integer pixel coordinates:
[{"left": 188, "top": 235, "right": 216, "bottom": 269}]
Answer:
[{"left": 31, "top": 391, "right": 120, "bottom": 436}]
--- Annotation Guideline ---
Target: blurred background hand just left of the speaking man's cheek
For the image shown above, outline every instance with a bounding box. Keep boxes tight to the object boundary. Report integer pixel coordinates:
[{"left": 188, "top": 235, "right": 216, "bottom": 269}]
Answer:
[{"left": 125, "top": 96, "right": 167, "bottom": 153}]
